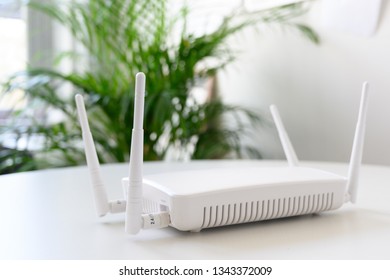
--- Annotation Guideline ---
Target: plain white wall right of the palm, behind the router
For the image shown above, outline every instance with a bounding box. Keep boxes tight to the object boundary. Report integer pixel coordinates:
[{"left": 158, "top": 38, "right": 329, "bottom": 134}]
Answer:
[{"left": 219, "top": 0, "right": 390, "bottom": 164}]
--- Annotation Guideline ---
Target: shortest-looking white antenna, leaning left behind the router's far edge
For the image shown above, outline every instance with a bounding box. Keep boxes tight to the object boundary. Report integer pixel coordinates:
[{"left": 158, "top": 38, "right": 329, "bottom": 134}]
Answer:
[{"left": 270, "top": 105, "right": 298, "bottom": 167}]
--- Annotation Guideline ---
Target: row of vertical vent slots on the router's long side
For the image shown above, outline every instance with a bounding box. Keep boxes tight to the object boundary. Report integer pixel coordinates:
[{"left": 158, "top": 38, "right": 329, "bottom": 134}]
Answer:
[{"left": 202, "top": 192, "right": 334, "bottom": 228}]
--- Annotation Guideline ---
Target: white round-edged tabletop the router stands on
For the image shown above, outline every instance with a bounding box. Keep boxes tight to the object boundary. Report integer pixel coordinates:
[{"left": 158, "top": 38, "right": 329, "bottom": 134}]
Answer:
[{"left": 0, "top": 161, "right": 390, "bottom": 260}]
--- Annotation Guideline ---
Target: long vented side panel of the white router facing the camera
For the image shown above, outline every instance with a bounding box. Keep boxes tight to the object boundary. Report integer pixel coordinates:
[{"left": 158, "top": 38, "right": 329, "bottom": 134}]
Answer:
[{"left": 170, "top": 180, "right": 346, "bottom": 231}]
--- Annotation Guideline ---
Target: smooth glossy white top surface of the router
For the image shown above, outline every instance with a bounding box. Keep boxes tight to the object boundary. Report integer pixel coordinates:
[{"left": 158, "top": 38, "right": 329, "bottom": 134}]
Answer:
[{"left": 146, "top": 166, "right": 345, "bottom": 195}]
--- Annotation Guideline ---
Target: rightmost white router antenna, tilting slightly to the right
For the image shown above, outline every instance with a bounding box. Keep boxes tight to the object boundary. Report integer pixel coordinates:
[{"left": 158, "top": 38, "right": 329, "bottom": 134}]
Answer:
[{"left": 347, "top": 82, "right": 368, "bottom": 203}]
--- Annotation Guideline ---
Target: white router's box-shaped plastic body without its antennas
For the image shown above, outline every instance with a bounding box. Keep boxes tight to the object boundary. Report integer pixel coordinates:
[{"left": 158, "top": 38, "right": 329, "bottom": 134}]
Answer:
[{"left": 123, "top": 165, "right": 347, "bottom": 231}]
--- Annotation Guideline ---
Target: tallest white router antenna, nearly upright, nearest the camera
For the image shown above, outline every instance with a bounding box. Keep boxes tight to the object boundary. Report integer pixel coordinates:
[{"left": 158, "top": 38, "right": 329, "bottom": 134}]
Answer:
[{"left": 125, "top": 73, "right": 145, "bottom": 234}]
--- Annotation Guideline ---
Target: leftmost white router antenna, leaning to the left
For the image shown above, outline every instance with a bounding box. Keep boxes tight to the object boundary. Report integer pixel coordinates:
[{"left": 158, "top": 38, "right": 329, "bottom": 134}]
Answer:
[{"left": 75, "top": 94, "right": 109, "bottom": 217}]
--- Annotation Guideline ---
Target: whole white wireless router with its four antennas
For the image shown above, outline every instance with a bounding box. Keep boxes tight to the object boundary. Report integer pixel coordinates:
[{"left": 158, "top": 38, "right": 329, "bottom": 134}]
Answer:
[{"left": 76, "top": 73, "right": 368, "bottom": 234}]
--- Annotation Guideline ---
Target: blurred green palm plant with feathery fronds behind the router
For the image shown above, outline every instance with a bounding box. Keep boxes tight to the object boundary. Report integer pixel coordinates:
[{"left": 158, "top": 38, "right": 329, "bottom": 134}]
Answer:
[{"left": 0, "top": 0, "right": 318, "bottom": 173}]
